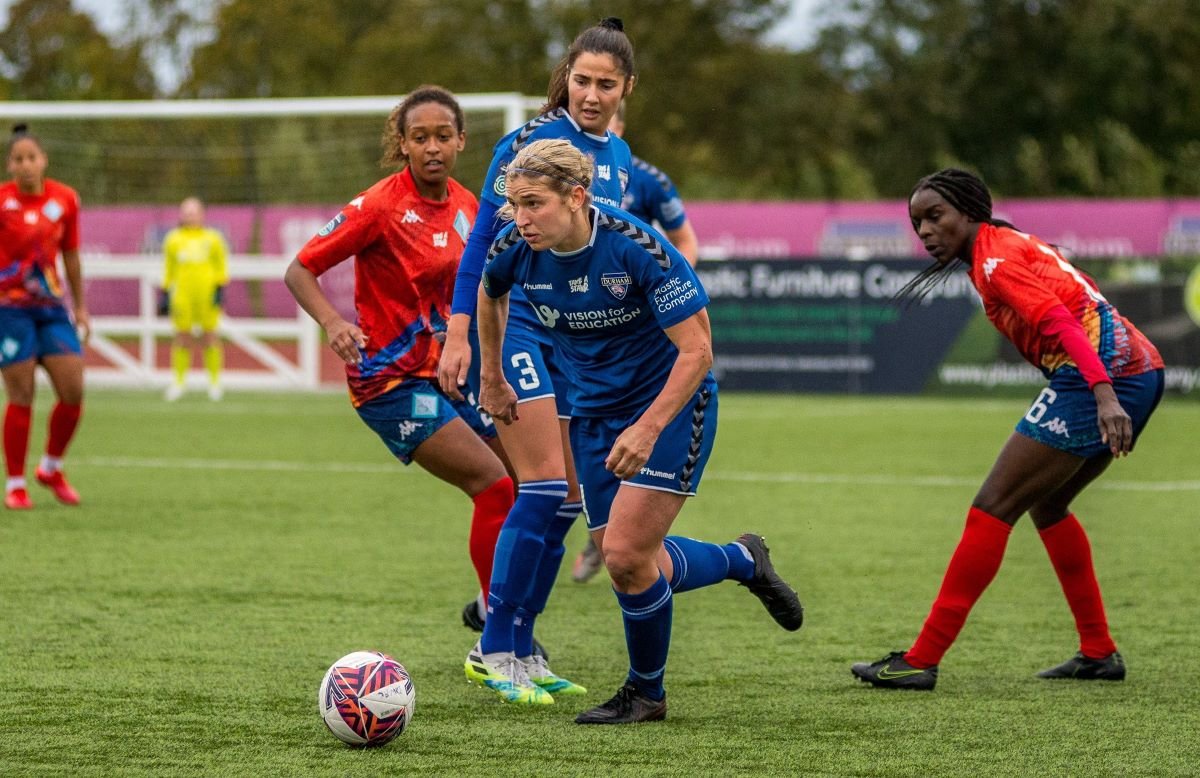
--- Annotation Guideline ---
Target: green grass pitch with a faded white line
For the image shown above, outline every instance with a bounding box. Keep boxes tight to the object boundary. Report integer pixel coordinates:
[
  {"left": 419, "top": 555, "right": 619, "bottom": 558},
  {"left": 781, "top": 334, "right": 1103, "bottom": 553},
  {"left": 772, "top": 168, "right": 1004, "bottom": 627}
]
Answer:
[{"left": 0, "top": 388, "right": 1200, "bottom": 776}]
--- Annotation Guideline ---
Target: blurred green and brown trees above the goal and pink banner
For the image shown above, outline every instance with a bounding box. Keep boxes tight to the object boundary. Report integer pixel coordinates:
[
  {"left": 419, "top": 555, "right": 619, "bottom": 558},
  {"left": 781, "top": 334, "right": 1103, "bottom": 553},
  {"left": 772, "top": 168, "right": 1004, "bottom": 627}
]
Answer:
[{"left": 0, "top": 0, "right": 1200, "bottom": 201}]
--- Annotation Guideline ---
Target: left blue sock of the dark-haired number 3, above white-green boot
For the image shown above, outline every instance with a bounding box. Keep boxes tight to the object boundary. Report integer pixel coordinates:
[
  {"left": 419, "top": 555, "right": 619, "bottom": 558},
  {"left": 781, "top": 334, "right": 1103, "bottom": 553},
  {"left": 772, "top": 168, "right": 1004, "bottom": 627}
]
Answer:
[{"left": 479, "top": 480, "right": 566, "bottom": 653}]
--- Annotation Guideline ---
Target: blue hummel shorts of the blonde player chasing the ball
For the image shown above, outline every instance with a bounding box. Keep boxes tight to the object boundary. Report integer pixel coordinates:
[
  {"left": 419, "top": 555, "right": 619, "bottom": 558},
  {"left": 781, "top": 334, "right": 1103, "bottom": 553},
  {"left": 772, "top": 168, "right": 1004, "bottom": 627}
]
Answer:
[{"left": 571, "top": 376, "right": 716, "bottom": 529}]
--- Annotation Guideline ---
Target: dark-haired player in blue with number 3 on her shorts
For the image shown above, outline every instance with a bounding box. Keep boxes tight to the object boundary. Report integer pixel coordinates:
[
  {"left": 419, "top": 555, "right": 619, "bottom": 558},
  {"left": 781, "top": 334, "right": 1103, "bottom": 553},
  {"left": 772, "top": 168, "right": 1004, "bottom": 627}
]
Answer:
[{"left": 438, "top": 18, "right": 635, "bottom": 702}]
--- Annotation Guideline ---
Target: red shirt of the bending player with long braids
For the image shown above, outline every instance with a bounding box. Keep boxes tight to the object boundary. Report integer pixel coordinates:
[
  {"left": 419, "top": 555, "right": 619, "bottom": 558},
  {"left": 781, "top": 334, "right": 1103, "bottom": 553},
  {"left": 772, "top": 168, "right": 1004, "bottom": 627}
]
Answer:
[{"left": 970, "top": 225, "right": 1163, "bottom": 378}]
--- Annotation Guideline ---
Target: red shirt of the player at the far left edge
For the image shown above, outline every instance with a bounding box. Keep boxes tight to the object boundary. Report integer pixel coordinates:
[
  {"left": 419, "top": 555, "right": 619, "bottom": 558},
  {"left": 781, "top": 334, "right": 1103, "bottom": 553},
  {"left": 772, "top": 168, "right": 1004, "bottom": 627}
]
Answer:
[{"left": 0, "top": 179, "right": 79, "bottom": 307}]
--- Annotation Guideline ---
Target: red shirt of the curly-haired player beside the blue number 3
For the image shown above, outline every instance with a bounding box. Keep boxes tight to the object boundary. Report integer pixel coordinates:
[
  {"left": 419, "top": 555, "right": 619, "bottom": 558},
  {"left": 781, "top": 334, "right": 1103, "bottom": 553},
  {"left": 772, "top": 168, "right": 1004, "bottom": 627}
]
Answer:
[{"left": 296, "top": 168, "right": 479, "bottom": 406}]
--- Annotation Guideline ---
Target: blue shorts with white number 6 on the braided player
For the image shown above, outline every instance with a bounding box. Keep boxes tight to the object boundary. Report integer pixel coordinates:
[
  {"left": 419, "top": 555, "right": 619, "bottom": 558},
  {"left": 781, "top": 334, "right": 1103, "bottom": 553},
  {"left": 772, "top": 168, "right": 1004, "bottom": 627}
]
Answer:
[{"left": 1016, "top": 367, "right": 1164, "bottom": 459}]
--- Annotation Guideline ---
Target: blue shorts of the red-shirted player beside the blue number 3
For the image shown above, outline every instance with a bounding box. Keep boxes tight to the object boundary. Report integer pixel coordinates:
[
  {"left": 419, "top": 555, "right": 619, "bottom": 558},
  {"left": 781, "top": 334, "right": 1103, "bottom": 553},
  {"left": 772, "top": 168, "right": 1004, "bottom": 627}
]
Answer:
[{"left": 355, "top": 378, "right": 496, "bottom": 465}]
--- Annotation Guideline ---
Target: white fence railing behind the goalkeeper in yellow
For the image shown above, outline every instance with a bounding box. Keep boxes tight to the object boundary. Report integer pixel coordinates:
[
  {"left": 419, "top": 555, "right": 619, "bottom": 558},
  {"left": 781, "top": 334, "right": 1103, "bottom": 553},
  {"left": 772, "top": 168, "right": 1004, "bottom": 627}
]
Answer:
[{"left": 84, "top": 255, "right": 320, "bottom": 390}]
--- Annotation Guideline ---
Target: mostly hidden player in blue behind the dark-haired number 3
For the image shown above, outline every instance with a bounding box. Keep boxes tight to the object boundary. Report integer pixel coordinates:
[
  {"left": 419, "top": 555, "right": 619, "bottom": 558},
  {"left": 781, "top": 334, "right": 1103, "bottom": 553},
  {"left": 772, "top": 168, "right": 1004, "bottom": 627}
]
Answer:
[{"left": 571, "top": 101, "right": 700, "bottom": 584}]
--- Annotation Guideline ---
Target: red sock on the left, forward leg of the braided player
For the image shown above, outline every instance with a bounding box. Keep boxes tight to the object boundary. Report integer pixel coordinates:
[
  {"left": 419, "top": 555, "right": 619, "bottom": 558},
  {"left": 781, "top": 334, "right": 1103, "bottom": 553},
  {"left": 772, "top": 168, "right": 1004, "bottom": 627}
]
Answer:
[{"left": 905, "top": 508, "right": 1013, "bottom": 668}]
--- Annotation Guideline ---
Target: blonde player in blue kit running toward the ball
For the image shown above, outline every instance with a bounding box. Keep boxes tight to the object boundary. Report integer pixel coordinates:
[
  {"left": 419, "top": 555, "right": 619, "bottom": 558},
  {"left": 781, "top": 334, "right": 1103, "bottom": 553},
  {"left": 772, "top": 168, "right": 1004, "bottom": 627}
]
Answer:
[{"left": 479, "top": 140, "right": 804, "bottom": 724}]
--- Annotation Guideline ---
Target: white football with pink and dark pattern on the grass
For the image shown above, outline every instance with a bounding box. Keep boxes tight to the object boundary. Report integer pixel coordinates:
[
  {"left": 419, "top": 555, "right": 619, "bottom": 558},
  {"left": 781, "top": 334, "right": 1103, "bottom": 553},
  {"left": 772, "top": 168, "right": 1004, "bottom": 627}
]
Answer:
[{"left": 317, "top": 651, "right": 416, "bottom": 746}]
